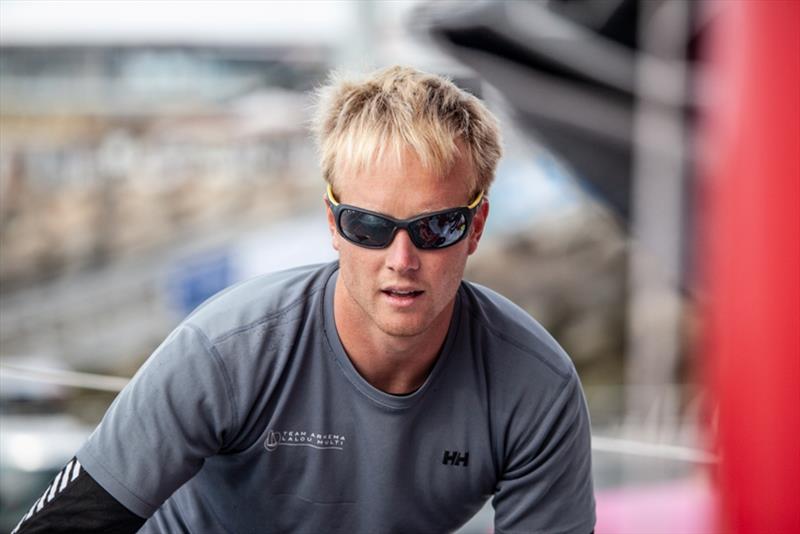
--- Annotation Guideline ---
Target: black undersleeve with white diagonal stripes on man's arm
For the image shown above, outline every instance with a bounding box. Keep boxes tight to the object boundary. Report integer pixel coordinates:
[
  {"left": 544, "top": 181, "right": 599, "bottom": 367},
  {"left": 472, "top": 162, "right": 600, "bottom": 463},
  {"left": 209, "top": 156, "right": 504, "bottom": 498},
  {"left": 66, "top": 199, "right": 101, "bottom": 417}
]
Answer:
[{"left": 12, "top": 458, "right": 146, "bottom": 534}]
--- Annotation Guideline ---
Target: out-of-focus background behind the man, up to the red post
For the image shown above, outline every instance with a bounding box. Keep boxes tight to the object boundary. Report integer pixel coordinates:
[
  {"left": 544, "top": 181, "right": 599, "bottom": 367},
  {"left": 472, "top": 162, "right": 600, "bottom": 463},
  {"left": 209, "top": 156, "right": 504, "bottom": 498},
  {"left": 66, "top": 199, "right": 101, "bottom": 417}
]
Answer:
[{"left": 0, "top": 0, "right": 800, "bottom": 534}]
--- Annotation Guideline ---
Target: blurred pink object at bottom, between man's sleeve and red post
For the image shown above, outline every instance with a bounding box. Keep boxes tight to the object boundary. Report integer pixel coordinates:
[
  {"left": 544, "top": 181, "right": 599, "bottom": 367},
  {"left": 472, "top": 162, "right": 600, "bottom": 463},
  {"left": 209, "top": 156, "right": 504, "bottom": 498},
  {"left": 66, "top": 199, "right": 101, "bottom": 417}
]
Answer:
[{"left": 595, "top": 475, "right": 719, "bottom": 534}]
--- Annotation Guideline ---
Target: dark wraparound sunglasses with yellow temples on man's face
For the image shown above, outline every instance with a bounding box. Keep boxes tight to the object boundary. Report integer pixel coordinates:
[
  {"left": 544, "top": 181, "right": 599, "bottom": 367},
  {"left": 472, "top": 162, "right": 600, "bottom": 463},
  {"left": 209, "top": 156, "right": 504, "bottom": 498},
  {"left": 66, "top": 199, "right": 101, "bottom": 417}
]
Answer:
[{"left": 328, "top": 184, "right": 483, "bottom": 250}]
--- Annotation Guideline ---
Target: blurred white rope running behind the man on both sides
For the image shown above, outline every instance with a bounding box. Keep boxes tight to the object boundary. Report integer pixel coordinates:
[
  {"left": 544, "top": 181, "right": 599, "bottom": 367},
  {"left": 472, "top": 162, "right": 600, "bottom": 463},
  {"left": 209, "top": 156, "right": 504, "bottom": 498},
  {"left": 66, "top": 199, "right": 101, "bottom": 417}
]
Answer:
[{"left": 0, "top": 364, "right": 718, "bottom": 464}]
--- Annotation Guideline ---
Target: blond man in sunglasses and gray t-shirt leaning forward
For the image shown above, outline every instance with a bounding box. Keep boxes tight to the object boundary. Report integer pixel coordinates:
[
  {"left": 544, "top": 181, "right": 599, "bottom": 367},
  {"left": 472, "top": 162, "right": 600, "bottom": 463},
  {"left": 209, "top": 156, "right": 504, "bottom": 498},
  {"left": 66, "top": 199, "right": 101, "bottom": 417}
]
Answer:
[{"left": 12, "top": 67, "right": 594, "bottom": 534}]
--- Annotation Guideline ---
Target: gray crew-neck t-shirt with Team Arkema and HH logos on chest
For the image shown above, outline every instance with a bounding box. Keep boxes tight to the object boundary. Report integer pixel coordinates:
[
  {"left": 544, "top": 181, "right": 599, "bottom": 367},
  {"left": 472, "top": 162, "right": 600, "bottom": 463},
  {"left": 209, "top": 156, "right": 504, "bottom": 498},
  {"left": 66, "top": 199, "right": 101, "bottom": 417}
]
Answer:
[{"left": 77, "top": 263, "right": 595, "bottom": 534}]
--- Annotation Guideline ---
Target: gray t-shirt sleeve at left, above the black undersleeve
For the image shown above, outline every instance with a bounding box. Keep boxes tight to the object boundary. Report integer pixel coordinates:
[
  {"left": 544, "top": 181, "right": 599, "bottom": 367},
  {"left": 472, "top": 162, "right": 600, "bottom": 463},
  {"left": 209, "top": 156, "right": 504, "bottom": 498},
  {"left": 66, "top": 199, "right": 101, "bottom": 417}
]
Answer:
[{"left": 77, "top": 324, "right": 237, "bottom": 518}]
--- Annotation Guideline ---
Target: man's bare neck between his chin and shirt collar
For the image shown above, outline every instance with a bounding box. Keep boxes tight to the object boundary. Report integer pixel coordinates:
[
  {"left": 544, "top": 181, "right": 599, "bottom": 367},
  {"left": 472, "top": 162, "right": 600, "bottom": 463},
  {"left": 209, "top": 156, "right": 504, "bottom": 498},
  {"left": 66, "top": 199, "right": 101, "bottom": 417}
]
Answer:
[{"left": 334, "top": 280, "right": 454, "bottom": 395}]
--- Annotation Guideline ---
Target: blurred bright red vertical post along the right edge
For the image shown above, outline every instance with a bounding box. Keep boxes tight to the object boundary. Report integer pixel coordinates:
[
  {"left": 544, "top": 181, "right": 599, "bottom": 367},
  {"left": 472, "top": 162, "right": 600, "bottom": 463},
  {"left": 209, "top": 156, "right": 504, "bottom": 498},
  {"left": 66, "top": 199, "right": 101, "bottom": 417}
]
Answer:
[{"left": 698, "top": 0, "right": 800, "bottom": 534}]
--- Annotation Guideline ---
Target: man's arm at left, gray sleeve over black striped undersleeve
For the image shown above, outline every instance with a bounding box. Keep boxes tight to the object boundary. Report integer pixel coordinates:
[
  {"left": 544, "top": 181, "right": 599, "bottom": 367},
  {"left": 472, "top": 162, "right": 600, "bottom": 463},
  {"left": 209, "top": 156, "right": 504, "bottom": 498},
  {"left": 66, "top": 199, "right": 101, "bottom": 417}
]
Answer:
[{"left": 18, "top": 326, "right": 236, "bottom": 533}]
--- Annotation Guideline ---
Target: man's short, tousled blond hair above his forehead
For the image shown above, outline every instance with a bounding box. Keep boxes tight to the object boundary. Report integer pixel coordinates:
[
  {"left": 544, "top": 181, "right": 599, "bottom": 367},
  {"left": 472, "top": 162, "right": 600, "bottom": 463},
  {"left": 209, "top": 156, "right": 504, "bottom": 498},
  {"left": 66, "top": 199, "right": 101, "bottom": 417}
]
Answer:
[{"left": 312, "top": 66, "right": 502, "bottom": 199}]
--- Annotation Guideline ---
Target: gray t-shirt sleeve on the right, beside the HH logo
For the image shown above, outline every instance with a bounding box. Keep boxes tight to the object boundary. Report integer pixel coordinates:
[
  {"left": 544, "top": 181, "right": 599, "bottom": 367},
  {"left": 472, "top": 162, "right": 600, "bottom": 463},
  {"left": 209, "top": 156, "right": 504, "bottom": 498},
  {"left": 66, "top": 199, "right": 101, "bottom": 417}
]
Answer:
[{"left": 492, "top": 375, "right": 595, "bottom": 534}]
